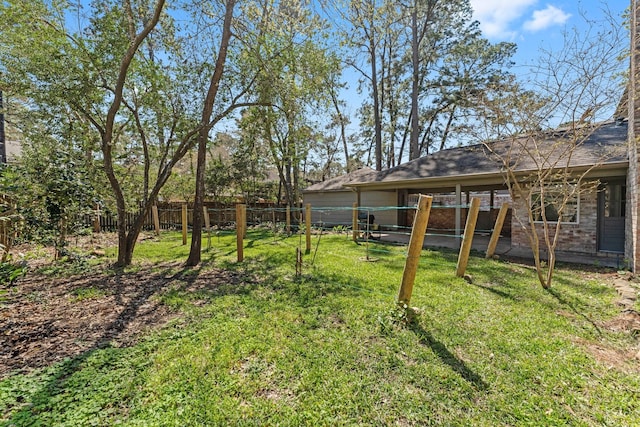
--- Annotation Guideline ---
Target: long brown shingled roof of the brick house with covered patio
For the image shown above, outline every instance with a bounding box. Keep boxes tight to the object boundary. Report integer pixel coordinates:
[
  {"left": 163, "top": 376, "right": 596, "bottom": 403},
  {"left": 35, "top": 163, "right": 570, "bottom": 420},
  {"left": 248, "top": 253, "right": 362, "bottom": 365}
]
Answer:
[{"left": 344, "top": 121, "right": 628, "bottom": 190}]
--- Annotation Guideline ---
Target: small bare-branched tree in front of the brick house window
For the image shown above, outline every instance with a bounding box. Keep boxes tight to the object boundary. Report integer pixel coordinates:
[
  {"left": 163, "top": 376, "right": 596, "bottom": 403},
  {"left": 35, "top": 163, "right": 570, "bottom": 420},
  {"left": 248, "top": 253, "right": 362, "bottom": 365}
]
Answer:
[{"left": 485, "top": 10, "right": 625, "bottom": 288}]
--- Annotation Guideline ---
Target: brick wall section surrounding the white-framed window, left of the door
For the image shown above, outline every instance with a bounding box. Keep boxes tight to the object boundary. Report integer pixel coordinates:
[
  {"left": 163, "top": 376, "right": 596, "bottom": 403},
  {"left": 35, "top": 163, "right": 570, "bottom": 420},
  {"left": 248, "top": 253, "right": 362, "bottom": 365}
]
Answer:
[{"left": 511, "top": 183, "right": 598, "bottom": 254}]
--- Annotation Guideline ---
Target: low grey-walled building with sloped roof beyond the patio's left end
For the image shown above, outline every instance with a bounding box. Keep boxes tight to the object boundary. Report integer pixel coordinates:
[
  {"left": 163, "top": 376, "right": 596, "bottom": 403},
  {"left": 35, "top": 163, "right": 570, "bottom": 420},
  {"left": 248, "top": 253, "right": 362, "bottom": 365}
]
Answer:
[{"left": 302, "top": 168, "right": 397, "bottom": 227}]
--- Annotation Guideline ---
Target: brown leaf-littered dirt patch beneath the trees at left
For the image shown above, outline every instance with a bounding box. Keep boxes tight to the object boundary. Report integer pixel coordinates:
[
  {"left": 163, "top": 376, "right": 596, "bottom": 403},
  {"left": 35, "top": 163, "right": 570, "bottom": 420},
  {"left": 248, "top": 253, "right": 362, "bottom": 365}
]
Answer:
[{"left": 0, "top": 264, "right": 245, "bottom": 378}]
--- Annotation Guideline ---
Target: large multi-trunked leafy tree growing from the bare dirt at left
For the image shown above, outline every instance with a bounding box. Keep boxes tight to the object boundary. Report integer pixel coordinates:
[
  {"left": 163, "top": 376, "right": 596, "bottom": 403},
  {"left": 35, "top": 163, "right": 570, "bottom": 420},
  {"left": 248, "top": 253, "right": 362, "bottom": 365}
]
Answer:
[{"left": 0, "top": 0, "right": 258, "bottom": 266}]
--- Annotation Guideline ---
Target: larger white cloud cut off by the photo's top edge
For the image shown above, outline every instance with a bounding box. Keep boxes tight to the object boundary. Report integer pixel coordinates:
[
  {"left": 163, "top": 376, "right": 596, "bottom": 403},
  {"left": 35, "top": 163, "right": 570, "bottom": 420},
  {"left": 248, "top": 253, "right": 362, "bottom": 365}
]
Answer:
[{"left": 471, "top": 0, "right": 538, "bottom": 39}]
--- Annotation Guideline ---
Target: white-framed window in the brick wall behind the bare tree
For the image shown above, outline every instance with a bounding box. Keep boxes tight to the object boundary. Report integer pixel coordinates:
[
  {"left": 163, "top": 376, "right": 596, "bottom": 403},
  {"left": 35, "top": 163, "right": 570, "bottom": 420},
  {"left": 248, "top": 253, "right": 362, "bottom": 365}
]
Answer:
[{"left": 531, "top": 184, "right": 580, "bottom": 224}]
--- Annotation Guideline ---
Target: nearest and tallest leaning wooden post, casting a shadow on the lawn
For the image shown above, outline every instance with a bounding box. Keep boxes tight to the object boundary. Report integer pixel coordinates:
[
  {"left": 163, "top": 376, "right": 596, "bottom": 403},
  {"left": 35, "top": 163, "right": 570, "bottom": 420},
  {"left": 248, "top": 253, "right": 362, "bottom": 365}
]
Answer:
[{"left": 398, "top": 194, "right": 433, "bottom": 308}]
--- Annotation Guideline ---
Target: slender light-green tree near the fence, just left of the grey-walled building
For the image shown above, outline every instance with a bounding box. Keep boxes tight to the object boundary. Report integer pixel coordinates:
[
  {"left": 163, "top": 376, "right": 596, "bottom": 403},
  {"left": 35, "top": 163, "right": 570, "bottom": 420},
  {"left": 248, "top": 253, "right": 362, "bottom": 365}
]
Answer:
[{"left": 239, "top": 0, "right": 339, "bottom": 211}]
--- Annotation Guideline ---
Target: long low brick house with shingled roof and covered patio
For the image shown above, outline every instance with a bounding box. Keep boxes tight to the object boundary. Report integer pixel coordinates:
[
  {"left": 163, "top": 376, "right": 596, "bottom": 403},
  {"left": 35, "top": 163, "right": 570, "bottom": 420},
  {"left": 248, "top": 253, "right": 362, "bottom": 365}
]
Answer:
[{"left": 306, "top": 120, "right": 629, "bottom": 263}]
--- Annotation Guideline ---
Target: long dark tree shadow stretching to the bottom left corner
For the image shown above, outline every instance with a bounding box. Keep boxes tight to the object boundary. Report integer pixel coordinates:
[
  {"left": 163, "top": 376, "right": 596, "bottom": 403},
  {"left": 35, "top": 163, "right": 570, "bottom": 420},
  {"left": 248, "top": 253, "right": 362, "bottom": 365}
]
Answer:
[{"left": 2, "top": 264, "right": 260, "bottom": 425}]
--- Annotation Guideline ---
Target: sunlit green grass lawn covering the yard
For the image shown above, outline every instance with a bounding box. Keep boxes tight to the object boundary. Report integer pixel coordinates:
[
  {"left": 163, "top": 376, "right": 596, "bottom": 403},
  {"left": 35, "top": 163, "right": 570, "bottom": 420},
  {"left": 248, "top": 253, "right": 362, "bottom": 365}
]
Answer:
[{"left": 0, "top": 231, "right": 640, "bottom": 426}]
